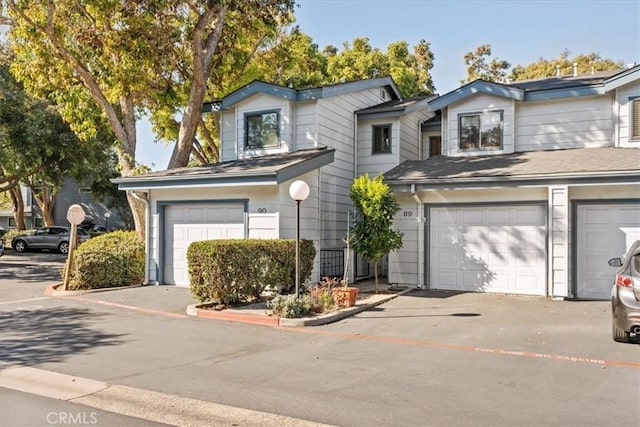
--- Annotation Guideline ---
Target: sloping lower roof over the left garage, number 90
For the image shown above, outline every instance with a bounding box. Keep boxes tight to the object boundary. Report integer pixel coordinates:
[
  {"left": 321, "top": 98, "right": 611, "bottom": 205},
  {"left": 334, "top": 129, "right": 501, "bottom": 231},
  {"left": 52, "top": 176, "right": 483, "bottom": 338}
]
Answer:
[{"left": 112, "top": 147, "right": 335, "bottom": 190}]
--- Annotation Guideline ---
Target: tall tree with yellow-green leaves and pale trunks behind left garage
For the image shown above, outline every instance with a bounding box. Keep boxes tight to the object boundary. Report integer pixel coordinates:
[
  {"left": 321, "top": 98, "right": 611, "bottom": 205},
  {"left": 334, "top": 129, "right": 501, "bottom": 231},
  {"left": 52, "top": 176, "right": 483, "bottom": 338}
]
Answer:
[{"left": 3, "top": 0, "right": 293, "bottom": 234}]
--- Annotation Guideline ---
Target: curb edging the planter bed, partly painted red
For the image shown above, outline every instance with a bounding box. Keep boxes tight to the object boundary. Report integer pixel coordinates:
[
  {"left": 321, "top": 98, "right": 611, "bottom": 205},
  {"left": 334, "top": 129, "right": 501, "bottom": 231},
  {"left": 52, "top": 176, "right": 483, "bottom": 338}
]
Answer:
[{"left": 186, "top": 288, "right": 413, "bottom": 328}]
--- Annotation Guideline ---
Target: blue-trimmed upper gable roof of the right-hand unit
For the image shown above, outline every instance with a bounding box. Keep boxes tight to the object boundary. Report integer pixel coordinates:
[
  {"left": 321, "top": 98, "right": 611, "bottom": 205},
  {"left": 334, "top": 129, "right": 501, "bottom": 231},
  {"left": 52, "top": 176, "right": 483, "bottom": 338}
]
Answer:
[{"left": 429, "top": 65, "right": 640, "bottom": 111}]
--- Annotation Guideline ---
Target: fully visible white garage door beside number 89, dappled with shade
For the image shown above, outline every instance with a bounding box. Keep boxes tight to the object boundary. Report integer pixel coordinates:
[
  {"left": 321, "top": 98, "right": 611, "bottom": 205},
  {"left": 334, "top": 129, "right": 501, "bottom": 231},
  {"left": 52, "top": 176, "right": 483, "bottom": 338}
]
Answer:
[{"left": 429, "top": 205, "right": 547, "bottom": 295}]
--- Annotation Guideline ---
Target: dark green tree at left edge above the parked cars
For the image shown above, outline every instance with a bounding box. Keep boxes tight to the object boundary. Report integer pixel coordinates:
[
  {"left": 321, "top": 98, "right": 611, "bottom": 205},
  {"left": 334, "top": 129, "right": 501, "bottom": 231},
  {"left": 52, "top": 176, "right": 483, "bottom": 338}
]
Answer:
[{"left": 0, "top": 45, "right": 113, "bottom": 228}]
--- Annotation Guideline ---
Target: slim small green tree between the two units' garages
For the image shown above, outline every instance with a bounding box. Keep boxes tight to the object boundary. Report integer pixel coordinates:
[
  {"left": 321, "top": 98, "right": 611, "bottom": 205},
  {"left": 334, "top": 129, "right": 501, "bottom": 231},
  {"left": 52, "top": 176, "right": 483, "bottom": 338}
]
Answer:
[{"left": 349, "top": 174, "right": 403, "bottom": 293}]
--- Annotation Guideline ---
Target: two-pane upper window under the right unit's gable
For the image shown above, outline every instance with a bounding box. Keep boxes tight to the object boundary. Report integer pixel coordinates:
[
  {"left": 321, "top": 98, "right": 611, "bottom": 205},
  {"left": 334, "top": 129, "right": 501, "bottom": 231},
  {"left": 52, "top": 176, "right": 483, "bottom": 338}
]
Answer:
[{"left": 458, "top": 111, "right": 502, "bottom": 150}]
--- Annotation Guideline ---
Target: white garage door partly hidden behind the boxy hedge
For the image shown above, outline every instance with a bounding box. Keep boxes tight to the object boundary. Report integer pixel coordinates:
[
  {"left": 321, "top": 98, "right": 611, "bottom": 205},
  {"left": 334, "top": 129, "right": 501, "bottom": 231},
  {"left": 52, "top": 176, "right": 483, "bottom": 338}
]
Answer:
[{"left": 163, "top": 204, "right": 245, "bottom": 286}]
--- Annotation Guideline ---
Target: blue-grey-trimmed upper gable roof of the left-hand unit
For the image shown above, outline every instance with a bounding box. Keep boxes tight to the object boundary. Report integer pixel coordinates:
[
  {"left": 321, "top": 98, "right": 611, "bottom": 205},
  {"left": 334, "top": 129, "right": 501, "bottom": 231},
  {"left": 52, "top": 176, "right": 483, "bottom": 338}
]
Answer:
[{"left": 202, "top": 77, "right": 402, "bottom": 112}]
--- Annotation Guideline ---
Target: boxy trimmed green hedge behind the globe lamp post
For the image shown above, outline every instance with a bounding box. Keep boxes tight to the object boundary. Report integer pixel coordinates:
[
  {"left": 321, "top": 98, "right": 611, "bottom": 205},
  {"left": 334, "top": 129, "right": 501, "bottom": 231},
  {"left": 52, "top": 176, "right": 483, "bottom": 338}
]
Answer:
[{"left": 187, "top": 239, "right": 316, "bottom": 305}]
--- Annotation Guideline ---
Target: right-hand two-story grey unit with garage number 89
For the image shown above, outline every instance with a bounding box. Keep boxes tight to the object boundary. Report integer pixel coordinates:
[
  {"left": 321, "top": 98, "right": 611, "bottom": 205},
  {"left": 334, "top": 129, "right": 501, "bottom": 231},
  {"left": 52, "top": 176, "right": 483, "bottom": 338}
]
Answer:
[{"left": 385, "top": 66, "right": 640, "bottom": 299}]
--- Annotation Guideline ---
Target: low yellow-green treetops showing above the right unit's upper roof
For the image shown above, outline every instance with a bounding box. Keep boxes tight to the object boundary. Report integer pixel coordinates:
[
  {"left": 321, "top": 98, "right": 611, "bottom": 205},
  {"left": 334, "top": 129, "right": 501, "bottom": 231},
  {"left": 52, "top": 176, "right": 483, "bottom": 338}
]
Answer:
[{"left": 510, "top": 49, "right": 623, "bottom": 80}]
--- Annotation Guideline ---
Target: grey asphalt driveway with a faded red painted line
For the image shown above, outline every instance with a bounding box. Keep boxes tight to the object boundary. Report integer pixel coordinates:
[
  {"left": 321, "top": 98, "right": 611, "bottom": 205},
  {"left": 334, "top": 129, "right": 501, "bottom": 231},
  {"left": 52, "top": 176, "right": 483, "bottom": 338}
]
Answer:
[{"left": 0, "top": 252, "right": 640, "bottom": 426}]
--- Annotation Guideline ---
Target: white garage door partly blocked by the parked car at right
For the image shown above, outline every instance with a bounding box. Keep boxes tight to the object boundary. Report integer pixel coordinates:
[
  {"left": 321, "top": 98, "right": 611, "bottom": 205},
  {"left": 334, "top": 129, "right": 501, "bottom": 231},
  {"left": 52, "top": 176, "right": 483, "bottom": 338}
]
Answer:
[{"left": 574, "top": 204, "right": 640, "bottom": 299}]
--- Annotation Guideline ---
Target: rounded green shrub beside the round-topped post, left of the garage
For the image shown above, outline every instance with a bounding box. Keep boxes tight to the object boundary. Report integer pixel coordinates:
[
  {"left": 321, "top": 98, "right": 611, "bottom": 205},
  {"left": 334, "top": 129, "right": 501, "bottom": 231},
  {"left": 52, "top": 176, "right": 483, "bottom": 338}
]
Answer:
[{"left": 69, "top": 231, "right": 145, "bottom": 290}]
